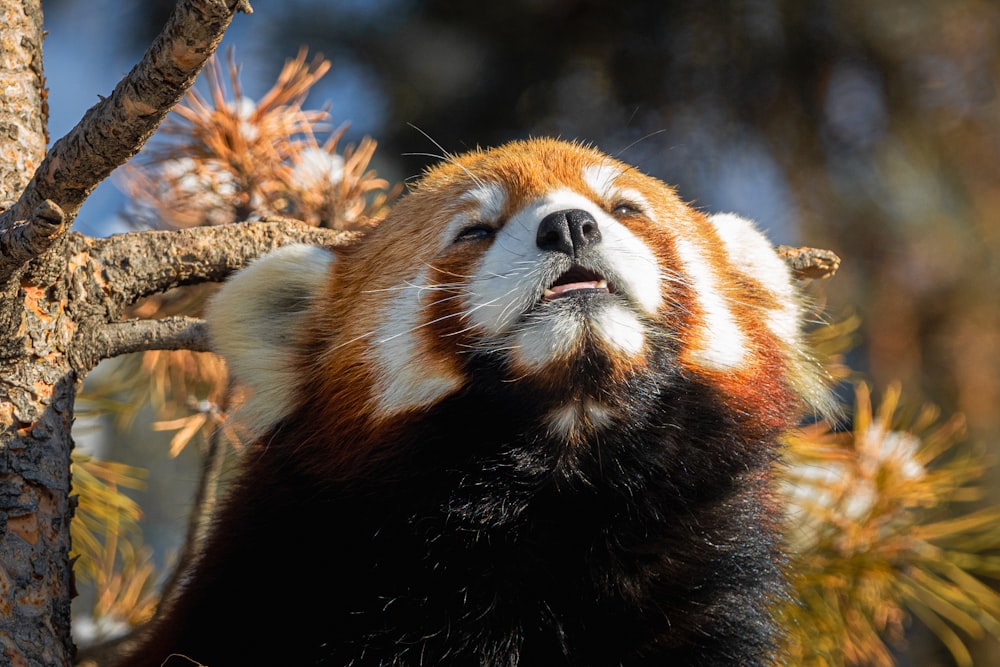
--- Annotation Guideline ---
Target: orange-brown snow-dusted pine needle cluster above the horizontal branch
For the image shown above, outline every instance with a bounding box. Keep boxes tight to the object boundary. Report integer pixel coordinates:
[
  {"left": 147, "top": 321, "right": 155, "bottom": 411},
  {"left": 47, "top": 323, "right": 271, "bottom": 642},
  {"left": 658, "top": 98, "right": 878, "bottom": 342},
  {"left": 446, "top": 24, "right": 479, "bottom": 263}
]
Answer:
[{"left": 123, "top": 45, "right": 398, "bottom": 229}]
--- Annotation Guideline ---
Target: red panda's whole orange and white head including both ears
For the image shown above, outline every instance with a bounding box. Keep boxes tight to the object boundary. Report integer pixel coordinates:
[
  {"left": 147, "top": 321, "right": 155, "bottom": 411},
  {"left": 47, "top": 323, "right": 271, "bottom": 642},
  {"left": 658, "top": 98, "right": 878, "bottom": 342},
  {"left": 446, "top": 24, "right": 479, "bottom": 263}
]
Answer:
[{"left": 209, "top": 139, "right": 826, "bottom": 462}]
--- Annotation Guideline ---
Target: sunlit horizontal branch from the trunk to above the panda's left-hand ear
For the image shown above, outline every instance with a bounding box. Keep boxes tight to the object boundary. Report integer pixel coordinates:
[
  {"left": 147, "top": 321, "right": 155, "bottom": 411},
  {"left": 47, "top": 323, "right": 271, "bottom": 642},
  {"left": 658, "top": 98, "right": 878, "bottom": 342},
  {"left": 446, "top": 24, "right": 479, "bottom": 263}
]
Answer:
[{"left": 89, "top": 219, "right": 358, "bottom": 305}]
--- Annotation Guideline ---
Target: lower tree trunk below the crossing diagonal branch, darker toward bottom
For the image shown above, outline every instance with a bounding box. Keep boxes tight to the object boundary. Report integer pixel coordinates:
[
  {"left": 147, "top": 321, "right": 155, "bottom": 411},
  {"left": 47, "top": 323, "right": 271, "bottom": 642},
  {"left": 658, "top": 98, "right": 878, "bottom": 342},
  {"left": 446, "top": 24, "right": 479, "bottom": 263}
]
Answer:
[{"left": 0, "top": 256, "right": 79, "bottom": 667}]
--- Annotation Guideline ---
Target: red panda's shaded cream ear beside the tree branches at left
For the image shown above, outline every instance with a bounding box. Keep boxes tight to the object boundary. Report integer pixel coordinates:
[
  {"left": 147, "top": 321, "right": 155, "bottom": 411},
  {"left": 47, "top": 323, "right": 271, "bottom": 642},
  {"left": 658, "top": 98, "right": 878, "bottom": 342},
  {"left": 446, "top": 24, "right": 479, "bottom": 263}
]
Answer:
[{"left": 206, "top": 245, "right": 335, "bottom": 436}]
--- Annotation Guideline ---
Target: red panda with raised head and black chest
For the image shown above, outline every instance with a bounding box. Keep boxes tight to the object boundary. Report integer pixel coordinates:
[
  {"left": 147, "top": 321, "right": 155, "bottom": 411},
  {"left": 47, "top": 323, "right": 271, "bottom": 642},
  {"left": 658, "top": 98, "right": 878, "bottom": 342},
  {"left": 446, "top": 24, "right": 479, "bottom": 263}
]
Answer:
[{"left": 117, "top": 139, "right": 826, "bottom": 667}]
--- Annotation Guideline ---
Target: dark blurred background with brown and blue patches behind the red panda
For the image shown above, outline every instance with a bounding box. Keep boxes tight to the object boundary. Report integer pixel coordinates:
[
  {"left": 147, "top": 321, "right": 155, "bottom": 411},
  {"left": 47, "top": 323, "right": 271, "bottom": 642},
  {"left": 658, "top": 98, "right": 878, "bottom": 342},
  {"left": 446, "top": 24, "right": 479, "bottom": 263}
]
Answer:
[{"left": 45, "top": 0, "right": 1000, "bottom": 666}]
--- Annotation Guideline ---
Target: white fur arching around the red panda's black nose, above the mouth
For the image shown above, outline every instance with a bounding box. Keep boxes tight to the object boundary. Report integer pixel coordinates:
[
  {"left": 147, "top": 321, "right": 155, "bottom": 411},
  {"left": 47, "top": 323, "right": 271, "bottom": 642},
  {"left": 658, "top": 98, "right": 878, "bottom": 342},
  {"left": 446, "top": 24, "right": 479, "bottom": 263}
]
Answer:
[{"left": 469, "top": 189, "right": 662, "bottom": 336}]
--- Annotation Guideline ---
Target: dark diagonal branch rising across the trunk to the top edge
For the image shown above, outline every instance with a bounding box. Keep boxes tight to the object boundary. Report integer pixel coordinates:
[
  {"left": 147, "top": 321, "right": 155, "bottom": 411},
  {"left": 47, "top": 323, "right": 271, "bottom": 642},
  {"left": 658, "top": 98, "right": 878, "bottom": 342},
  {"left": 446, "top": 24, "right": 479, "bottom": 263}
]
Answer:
[{"left": 0, "top": 0, "right": 251, "bottom": 273}]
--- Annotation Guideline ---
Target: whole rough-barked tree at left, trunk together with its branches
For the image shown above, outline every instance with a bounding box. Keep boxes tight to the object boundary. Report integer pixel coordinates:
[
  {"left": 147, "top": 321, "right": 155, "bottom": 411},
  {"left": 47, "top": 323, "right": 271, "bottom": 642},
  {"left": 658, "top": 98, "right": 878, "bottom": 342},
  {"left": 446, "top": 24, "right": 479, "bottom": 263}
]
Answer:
[{"left": 0, "top": 0, "right": 356, "bottom": 667}]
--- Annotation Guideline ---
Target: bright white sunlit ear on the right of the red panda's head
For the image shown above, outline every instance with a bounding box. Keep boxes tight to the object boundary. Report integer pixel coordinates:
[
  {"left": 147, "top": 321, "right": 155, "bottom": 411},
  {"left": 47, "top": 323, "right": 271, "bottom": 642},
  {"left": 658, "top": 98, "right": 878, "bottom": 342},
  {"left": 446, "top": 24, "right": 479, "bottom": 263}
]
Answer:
[{"left": 709, "top": 213, "right": 799, "bottom": 343}]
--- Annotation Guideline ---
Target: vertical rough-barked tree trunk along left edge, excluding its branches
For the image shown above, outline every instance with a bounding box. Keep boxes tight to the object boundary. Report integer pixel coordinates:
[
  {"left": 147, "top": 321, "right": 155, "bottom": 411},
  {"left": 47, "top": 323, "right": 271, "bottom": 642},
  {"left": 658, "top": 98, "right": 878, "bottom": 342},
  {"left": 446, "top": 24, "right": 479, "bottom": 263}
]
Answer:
[{"left": 0, "top": 0, "right": 78, "bottom": 666}]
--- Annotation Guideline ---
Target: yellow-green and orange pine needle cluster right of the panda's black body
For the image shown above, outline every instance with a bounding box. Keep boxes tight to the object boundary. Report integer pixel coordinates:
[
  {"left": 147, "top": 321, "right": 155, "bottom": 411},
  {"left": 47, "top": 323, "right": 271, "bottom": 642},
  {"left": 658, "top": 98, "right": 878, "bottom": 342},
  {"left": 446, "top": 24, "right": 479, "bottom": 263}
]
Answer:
[{"left": 781, "top": 383, "right": 1000, "bottom": 667}]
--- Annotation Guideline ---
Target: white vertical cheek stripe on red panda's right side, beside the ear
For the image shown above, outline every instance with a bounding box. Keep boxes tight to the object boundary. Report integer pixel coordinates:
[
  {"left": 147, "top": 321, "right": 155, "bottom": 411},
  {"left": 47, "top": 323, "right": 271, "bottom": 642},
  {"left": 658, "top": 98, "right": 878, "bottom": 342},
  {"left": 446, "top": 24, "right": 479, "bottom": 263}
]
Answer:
[{"left": 675, "top": 238, "right": 747, "bottom": 371}]
